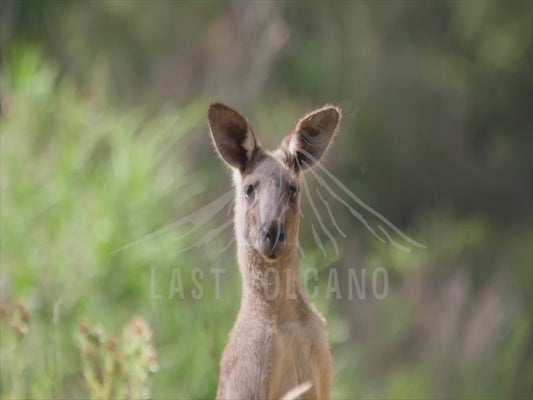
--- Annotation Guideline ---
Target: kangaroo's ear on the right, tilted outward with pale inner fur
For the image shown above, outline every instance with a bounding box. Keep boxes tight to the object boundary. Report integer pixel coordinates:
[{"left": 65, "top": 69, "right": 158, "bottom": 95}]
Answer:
[{"left": 282, "top": 106, "right": 342, "bottom": 170}]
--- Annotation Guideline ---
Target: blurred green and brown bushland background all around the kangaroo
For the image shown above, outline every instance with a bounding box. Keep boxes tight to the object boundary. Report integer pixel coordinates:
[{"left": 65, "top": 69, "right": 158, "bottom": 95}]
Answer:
[{"left": 0, "top": 0, "right": 533, "bottom": 399}]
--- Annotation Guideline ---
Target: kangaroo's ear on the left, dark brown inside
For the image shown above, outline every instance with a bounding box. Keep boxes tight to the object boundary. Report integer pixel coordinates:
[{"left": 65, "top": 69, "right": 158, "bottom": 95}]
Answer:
[{"left": 207, "top": 103, "right": 257, "bottom": 172}]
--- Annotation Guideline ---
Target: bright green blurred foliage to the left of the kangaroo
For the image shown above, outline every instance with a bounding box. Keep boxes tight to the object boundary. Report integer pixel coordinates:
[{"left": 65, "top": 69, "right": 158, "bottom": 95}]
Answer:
[{"left": 0, "top": 48, "right": 239, "bottom": 398}]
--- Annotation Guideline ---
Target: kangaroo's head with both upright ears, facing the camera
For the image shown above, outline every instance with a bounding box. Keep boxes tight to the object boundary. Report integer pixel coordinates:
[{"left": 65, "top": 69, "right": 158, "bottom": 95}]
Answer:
[{"left": 208, "top": 103, "right": 341, "bottom": 260}]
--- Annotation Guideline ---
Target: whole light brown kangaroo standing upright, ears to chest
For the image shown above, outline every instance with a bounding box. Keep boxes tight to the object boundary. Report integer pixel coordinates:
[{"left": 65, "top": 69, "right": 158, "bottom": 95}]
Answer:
[{"left": 208, "top": 103, "right": 341, "bottom": 399}]
